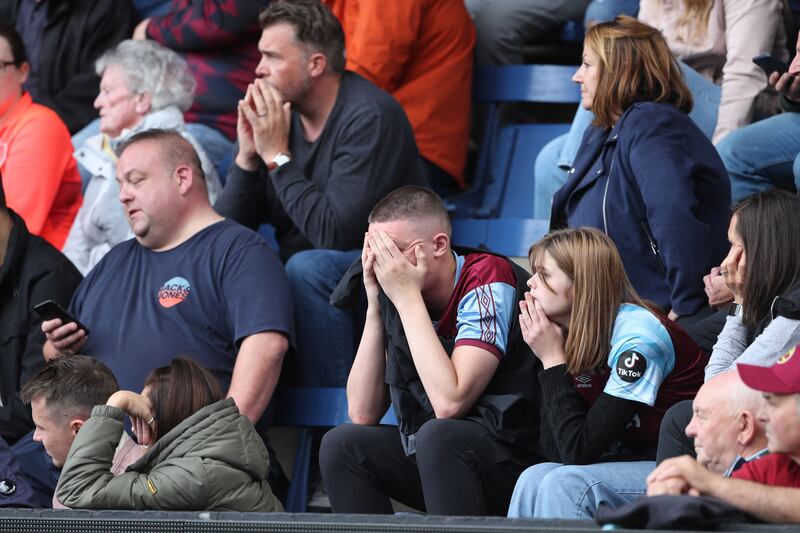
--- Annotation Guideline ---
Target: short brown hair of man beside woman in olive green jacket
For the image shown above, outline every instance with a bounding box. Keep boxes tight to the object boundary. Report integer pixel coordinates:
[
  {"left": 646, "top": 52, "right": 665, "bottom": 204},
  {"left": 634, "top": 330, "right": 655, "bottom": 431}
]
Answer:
[{"left": 20, "top": 355, "right": 119, "bottom": 418}]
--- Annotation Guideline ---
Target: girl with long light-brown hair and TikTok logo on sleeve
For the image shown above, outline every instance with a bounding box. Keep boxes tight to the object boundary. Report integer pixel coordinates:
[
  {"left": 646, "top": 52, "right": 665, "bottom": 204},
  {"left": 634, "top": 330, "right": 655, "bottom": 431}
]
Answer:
[{"left": 509, "top": 228, "right": 708, "bottom": 518}]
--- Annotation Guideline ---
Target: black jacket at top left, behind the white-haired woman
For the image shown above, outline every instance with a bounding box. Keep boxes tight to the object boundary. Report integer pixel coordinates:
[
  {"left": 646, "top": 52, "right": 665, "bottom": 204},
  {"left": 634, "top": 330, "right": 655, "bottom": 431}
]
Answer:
[{"left": 0, "top": 0, "right": 138, "bottom": 134}]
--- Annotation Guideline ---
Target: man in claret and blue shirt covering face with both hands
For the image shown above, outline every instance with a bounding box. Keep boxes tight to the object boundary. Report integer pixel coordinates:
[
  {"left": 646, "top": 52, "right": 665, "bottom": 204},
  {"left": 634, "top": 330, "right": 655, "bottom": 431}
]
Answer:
[{"left": 320, "top": 187, "right": 539, "bottom": 515}]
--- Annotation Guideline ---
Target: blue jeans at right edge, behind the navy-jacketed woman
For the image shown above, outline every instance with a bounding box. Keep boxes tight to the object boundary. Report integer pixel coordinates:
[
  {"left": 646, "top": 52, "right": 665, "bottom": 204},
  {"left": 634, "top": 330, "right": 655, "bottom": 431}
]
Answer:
[{"left": 717, "top": 113, "right": 800, "bottom": 204}]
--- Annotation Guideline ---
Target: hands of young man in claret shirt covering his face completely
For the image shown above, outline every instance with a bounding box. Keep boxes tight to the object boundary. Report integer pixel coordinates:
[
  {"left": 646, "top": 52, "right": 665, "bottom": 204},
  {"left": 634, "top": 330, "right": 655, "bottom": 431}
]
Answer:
[{"left": 361, "top": 231, "right": 428, "bottom": 307}]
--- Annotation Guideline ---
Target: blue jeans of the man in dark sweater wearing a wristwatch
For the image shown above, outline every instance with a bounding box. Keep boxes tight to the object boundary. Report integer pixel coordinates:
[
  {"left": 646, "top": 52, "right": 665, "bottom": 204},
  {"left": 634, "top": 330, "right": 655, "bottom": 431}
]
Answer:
[{"left": 286, "top": 250, "right": 366, "bottom": 387}]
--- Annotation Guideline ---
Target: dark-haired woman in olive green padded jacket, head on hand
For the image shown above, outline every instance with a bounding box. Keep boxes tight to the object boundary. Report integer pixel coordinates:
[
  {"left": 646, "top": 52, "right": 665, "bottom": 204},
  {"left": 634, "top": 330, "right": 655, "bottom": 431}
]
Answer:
[{"left": 56, "top": 357, "right": 282, "bottom": 512}]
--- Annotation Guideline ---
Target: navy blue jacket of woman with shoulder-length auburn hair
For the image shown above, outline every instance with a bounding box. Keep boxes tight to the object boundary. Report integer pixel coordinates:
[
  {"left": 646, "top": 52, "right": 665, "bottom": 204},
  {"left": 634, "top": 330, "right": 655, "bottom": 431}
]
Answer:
[{"left": 551, "top": 102, "right": 731, "bottom": 315}]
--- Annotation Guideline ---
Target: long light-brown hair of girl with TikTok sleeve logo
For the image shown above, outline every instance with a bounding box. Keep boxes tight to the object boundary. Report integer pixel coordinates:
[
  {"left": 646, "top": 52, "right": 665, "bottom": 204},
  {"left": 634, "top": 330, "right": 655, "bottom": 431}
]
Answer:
[{"left": 529, "top": 228, "right": 651, "bottom": 375}]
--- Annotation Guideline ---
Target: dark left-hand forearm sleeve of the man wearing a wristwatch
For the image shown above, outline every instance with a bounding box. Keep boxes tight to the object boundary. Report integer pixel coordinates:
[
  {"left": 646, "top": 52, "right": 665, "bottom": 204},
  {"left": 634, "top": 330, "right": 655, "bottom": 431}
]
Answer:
[{"left": 214, "top": 160, "right": 268, "bottom": 230}]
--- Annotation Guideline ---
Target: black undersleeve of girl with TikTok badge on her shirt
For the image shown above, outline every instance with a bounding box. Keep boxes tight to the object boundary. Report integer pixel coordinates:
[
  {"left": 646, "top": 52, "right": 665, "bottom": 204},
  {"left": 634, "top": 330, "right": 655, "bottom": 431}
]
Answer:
[{"left": 539, "top": 365, "right": 640, "bottom": 465}]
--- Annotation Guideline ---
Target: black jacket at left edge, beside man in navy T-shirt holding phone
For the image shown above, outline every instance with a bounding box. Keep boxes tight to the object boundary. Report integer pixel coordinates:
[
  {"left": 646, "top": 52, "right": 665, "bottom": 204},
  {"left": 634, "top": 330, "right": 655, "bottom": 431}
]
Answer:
[{"left": 0, "top": 210, "right": 82, "bottom": 443}]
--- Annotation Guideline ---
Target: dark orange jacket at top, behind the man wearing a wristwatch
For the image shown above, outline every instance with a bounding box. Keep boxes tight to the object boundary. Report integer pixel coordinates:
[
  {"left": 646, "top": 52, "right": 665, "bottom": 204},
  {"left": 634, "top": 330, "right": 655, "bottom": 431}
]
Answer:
[{"left": 325, "top": 0, "right": 475, "bottom": 186}]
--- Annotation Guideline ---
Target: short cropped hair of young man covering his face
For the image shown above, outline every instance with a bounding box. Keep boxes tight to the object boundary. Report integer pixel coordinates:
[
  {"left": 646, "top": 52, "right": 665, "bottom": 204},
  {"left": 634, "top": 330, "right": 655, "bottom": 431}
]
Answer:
[{"left": 367, "top": 185, "right": 450, "bottom": 235}]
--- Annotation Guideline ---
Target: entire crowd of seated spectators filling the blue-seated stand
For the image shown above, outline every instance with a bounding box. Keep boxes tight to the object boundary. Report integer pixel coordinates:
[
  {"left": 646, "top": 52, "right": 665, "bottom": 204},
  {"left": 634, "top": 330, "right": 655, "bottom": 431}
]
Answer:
[{"left": 0, "top": 0, "right": 800, "bottom": 522}]
